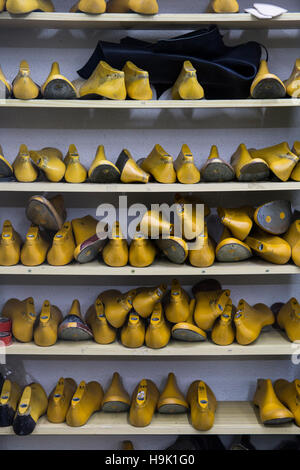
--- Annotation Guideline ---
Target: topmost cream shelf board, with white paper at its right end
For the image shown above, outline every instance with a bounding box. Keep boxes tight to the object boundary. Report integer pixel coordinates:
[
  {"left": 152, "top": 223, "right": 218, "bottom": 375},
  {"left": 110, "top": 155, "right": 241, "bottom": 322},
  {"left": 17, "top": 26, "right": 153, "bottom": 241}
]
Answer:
[{"left": 0, "top": 12, "right": 300, "bottom": 30}]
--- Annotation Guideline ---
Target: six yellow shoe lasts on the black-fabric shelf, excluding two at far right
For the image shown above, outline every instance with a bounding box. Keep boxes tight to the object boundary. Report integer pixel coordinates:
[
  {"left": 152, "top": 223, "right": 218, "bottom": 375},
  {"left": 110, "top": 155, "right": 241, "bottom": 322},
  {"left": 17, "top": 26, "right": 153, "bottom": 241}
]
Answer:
[{"left": 0, "top": 60, "right": 204, "bottom": 100}]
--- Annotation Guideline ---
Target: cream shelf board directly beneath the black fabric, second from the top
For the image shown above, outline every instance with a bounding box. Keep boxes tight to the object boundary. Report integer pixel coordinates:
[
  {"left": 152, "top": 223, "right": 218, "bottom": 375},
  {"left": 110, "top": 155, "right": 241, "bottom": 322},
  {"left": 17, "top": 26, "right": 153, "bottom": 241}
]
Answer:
[{"left": 0, "top": 98, "right": 300, "bottom": 109}]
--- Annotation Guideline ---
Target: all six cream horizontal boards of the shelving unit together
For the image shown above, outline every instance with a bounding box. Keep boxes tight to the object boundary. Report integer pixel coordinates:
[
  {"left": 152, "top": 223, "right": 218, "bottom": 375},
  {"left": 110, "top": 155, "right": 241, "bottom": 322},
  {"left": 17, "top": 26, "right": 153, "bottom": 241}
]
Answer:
[{"left": 0, "top": 6, "right": 300, "bottom": 444}]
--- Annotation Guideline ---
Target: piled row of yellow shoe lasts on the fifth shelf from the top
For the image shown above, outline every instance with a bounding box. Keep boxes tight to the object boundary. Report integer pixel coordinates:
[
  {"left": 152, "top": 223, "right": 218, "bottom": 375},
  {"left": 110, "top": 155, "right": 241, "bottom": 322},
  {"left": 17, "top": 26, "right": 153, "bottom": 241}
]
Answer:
[{"left": 1, "top": 279, "right": 300, "bottom": 349}]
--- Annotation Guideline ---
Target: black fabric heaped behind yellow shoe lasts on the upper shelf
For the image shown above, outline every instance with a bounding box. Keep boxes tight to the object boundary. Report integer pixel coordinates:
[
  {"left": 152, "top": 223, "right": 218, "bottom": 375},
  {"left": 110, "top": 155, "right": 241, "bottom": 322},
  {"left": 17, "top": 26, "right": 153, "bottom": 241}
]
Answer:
[{"left": 78, "top": 26, "right": 261, "bottom": 99}]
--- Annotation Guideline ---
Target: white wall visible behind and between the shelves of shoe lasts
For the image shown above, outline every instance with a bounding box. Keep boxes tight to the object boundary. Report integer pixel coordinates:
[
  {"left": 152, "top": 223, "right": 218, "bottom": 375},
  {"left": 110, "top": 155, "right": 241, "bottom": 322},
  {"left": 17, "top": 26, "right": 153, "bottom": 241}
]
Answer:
[{"left": 0, "top": 0, "right": 300, "bottom": 449}]
